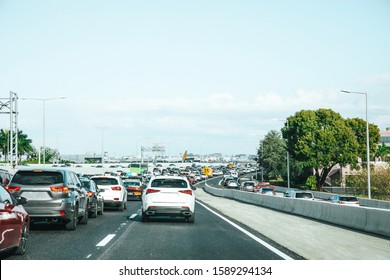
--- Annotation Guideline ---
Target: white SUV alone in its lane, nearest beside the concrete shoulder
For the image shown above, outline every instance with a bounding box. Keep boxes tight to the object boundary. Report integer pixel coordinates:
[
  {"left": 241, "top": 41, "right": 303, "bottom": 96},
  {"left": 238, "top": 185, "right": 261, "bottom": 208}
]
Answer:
[{"left": 142, "top": 176, "right": 195, "bottom": 223}]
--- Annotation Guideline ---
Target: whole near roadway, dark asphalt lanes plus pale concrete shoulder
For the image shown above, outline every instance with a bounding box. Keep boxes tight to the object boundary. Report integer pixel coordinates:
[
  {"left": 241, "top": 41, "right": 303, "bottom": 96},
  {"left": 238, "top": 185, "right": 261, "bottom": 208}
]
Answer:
[{"left": 2, "top": 175, "right": 390, "bottom": 260}]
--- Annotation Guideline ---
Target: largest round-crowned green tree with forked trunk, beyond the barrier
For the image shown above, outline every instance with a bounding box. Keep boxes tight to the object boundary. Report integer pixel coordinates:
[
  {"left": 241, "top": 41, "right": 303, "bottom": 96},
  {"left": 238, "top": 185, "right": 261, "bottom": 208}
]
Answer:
[{"left": 282, "top": 109, "right": 359, "bottom": 190}]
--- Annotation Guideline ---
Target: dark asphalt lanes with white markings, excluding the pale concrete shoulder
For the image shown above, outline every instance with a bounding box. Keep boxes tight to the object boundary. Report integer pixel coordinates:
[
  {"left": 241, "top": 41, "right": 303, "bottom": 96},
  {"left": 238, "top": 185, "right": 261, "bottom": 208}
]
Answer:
[{"left": 3, "top": 182, "right": 299, "bottom": 260}]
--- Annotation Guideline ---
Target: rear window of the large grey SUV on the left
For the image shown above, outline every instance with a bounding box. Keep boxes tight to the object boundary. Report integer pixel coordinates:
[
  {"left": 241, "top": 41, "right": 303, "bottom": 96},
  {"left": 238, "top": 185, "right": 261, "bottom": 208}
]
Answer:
[{"left": 12, "top": 171, "right": 64, "bottom": 186}]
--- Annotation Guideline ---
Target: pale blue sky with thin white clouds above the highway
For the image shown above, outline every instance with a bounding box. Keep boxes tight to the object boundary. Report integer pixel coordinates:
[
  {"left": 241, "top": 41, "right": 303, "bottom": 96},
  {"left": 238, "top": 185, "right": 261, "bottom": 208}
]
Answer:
[{"left": 0, "top": 0, "right": 390, "bottom": 157}]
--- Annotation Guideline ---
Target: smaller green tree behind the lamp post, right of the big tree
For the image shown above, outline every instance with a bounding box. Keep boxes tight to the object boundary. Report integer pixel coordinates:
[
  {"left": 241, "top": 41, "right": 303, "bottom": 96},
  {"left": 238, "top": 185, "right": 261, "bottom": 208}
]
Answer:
[{"left": 346, "top": 118, "right": 380, "bottom": 162}]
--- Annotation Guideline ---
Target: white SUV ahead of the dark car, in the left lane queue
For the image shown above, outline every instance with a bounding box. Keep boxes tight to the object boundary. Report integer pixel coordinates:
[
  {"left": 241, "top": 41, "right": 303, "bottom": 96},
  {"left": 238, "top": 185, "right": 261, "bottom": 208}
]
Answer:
[{"left": 90, "top": 176, "right": 127, "bottom": 211}]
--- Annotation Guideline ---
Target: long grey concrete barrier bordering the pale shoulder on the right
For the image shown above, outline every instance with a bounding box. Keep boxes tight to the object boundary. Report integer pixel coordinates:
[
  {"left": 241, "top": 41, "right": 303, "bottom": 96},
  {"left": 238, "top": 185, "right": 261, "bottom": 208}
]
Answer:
[{"left": 204, "top": 183, "right": 390, "bottom": 237}]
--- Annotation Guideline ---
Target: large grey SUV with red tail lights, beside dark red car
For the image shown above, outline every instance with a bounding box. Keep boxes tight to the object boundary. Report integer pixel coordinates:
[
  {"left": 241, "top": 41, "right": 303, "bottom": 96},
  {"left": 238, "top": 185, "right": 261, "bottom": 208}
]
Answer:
[{"left": 7, "top": 169, "right": 88, "bottom": 230}]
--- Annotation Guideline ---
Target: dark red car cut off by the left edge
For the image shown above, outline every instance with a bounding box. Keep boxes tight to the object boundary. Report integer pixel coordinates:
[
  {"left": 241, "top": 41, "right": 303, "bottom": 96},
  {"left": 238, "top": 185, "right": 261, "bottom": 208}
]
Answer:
[{"left": 0, "top": 186, "right": 30, "bottom": 255}]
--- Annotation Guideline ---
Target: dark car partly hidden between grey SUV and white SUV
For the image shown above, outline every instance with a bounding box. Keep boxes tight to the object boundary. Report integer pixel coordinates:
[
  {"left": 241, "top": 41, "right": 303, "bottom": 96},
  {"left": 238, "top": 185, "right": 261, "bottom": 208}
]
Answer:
[{"left": 80, "top": 177, "right": 104, "bottom": 218}]
